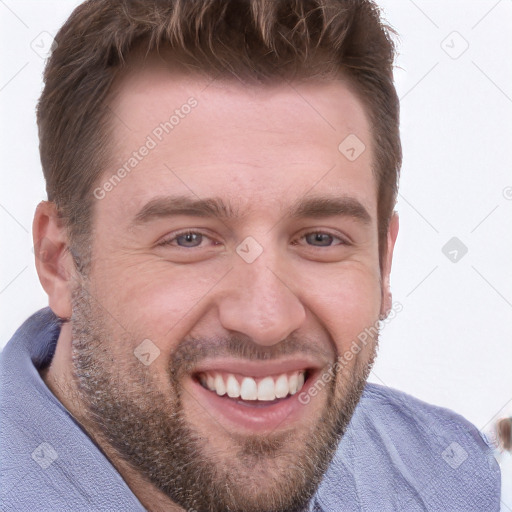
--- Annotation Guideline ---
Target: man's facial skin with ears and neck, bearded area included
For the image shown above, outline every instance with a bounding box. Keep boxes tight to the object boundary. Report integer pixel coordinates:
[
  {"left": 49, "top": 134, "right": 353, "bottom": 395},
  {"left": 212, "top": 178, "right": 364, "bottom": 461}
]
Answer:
[{"left": 33, "top": 58, "right": 398, "bottom": 512}]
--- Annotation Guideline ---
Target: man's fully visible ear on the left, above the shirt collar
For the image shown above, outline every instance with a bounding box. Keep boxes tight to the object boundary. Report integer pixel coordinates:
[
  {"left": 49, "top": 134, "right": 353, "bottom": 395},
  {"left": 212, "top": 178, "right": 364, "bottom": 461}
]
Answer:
[{"left": 32, "top": 201, "right": 76, "bottom": 319}]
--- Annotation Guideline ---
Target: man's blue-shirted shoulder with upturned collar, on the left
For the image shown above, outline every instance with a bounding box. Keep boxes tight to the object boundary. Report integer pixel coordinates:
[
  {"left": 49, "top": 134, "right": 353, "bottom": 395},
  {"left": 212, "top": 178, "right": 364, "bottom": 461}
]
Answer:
[{"left": 0, "top": 308, "right": 144, "bottom": 512}]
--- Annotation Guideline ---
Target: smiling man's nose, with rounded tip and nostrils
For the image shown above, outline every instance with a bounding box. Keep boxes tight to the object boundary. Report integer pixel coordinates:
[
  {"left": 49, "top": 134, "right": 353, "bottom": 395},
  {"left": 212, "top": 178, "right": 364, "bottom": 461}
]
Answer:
[{"left": 219, "top": 258, "right": 306, "bottom": 346}]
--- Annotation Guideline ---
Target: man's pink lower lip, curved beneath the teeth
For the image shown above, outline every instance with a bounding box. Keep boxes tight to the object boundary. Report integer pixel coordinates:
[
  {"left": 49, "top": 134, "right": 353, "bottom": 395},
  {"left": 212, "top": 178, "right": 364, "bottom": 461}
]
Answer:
[{"left": 186, "top": 374, "right": 315, "bottom": 432}]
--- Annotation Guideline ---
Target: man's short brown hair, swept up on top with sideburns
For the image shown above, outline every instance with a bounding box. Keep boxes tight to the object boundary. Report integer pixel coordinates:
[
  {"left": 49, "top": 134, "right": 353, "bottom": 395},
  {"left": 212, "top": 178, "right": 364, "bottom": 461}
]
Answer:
[{"left": 37, "top": 0, "right": 401, "bottom": 268}]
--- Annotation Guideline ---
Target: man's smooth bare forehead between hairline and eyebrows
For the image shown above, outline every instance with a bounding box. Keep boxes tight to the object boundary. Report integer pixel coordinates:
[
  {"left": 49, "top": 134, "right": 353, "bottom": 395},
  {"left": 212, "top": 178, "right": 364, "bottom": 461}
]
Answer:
[{"left": 100, "top": 58, "right": 376, "bottom": 222}]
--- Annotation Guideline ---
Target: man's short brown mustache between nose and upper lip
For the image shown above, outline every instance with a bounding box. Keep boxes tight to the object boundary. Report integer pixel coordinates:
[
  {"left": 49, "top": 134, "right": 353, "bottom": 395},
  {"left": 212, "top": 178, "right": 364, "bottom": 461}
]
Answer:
[{"left": 169, "top": 334, "right": 336, "bottom": 378}]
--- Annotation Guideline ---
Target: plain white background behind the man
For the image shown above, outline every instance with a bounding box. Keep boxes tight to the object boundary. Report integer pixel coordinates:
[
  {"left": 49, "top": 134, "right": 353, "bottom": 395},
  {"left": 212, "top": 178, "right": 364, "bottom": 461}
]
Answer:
[{"left": 0, "top": 0, "right": 512, "bottom": 504}]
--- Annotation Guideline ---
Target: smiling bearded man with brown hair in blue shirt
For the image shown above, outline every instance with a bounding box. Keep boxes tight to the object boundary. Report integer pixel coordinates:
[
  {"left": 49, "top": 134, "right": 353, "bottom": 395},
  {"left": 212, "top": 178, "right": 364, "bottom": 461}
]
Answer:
[{"left": 0, "top": 0, "right": 500, "bottom": 512}]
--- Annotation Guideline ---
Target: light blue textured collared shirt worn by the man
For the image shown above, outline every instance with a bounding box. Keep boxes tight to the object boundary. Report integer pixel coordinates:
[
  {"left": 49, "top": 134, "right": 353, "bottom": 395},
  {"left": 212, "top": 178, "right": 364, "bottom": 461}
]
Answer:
[{"left": 0, "top": 308, "right": 500, "bottom": 512}]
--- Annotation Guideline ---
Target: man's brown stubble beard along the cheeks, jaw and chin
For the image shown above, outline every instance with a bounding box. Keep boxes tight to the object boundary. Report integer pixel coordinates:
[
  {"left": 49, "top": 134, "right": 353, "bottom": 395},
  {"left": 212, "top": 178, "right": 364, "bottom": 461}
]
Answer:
[{"left": 71, "top": 287, "right": 377, "bottom": 512}]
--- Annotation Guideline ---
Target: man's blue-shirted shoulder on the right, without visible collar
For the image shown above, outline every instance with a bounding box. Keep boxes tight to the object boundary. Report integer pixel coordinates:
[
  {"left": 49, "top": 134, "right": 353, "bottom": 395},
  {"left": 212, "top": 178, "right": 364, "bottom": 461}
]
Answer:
[{"left": 312, "top": 383, "right": 501, "bottom": 512}]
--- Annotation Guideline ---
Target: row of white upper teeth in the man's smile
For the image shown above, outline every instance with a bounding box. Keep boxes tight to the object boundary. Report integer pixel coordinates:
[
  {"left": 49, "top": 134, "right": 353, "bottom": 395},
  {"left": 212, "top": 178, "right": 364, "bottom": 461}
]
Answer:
[{"left": 199, "top": 370, "right": 305, "bottom": 401}]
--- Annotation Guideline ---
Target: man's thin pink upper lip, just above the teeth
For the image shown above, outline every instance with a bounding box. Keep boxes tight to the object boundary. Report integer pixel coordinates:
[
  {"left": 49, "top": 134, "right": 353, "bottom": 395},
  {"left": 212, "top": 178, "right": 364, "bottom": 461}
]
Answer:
[{"left": 192, "top": 357, "right": 323, "bottom": 377}]
